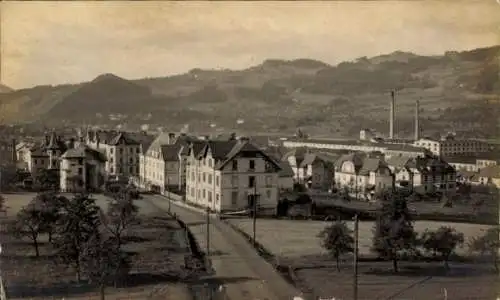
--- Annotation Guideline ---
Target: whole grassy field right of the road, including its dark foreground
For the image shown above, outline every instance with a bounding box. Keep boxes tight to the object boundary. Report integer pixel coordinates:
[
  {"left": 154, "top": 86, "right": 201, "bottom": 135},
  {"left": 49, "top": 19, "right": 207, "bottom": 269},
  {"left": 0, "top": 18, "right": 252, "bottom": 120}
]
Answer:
[{"left": 228, "top": 219, "right": 498, "bottom": 300}]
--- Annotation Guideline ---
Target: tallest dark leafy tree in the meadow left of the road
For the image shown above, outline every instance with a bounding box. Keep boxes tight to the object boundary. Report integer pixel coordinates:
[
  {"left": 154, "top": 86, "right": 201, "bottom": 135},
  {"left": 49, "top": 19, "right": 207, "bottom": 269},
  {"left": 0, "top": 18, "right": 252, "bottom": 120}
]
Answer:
[{"left": 53, "top": 194, "right": 100, "bottom": 281}]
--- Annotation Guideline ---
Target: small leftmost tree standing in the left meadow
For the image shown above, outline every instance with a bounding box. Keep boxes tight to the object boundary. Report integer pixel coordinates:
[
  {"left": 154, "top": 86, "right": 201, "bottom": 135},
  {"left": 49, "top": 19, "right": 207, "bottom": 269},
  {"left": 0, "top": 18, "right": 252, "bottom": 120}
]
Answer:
[{"left": 14, "top": 203, "right": 45, "bottom": 257}]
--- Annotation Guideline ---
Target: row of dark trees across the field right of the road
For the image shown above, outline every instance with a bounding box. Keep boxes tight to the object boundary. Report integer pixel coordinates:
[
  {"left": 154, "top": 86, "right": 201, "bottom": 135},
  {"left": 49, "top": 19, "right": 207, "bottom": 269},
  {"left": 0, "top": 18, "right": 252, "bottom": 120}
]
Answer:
[{"left": 318, "top": 191, "right": 500, "bottom": 272}]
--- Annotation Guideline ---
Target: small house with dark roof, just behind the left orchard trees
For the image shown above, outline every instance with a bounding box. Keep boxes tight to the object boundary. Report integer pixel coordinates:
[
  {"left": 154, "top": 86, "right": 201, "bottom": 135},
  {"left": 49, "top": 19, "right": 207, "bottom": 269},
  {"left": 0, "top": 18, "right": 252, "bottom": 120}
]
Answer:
[{"left": 59, "top": 145, "right": 106, "bottom": 192}]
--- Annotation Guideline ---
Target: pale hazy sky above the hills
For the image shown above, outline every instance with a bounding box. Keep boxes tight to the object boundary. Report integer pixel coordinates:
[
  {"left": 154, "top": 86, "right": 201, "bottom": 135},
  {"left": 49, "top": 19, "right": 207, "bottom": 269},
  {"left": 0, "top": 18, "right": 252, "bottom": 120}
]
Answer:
[{"left": 0, "top": 0, "right": 500, "bottom": 88}]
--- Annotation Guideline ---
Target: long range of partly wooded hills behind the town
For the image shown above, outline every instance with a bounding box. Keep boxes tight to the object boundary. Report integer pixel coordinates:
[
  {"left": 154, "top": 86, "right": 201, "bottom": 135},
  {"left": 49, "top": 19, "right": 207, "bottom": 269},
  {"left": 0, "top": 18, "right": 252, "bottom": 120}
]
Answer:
[{"left": 0, "top": 46, "right": 500, "bottom": 137}]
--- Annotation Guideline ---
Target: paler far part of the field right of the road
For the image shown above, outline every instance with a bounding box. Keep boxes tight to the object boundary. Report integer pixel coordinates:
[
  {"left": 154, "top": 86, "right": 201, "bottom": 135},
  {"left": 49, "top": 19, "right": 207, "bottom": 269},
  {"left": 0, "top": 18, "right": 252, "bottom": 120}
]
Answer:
[{"left": 228, "top": 218, "right": 490, "bottom": 257}]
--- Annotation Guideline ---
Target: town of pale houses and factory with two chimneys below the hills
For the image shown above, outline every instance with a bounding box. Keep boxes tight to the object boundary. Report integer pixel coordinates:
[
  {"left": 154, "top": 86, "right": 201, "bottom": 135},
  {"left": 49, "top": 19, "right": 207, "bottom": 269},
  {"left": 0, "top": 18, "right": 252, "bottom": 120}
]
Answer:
[{"left": 1, "top": 92, "right": 500, "bottom": 299}]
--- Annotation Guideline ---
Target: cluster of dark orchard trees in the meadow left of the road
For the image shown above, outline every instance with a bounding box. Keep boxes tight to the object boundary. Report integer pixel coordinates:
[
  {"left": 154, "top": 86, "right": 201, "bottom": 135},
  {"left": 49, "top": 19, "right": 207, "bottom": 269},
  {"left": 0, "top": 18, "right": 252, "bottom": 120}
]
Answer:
[{"left": 4, "top": 189, "right": 138, "bottom": 299}]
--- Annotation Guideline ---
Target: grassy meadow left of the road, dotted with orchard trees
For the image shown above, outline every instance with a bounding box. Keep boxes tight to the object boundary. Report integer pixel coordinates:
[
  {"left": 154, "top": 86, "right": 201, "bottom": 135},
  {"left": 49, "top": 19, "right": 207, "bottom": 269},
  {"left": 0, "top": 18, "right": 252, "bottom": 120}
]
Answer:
[{"left": 0, "top": 193, "right": 197, "bottom": 299}]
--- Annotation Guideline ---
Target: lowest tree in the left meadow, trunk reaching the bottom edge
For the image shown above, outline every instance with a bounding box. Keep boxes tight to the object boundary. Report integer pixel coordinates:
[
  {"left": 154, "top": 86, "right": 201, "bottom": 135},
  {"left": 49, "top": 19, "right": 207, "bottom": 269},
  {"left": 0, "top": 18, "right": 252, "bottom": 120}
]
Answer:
[{"left": 81, "top": 233, "right": 130, "bottom": 300}]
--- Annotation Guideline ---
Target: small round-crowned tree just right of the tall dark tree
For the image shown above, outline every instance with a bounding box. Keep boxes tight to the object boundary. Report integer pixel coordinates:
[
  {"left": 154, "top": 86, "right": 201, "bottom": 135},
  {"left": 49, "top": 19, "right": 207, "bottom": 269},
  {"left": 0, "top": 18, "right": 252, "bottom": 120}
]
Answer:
[{"left": 421, "top": 226, "right": 464, "bottom": 269}]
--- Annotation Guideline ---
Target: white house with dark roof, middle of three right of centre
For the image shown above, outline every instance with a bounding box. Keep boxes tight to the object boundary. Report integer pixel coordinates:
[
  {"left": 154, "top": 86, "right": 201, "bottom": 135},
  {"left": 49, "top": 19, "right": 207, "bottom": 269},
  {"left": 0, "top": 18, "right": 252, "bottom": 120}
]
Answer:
[{"left": 335, "top": 153, "right": 393, "bottom": 199}]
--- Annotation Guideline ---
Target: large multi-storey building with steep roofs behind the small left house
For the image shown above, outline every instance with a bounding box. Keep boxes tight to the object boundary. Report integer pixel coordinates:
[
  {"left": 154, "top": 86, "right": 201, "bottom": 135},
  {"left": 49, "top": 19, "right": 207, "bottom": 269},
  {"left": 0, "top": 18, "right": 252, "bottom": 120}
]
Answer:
[{"left": 85, "top": 130, "right": 154, "bottom": 177}]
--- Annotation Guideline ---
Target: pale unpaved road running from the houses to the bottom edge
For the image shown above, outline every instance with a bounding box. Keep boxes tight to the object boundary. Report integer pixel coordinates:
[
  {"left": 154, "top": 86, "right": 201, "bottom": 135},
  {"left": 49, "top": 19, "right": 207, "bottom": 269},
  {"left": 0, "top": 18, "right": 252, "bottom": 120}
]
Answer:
[{"left": 143, "top": 195, "right": 300, "bottom": 300}]
